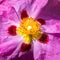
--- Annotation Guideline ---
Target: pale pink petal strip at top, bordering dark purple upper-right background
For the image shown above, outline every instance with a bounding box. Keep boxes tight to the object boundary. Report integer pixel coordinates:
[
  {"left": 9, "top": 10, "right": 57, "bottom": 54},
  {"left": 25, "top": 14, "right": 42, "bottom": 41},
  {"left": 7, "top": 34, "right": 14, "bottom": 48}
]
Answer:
[{"left": 29, "top": 0, "right": 48, "bottom": 18}]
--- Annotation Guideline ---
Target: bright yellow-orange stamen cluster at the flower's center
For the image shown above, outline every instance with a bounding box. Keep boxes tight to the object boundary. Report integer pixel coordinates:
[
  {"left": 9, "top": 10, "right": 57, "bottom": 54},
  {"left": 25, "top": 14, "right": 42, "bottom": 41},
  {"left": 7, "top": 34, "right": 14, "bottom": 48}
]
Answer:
[{"left": 17, "top": 18, "right": 41, "bottom": 43}]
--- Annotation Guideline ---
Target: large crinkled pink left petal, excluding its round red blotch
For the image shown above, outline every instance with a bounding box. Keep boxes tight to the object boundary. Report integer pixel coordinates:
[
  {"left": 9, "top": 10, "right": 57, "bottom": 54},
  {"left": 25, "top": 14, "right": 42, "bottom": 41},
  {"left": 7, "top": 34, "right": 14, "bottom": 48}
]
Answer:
[{"left": 0, "top": 3, "right": 21, "bottom": 60}]
